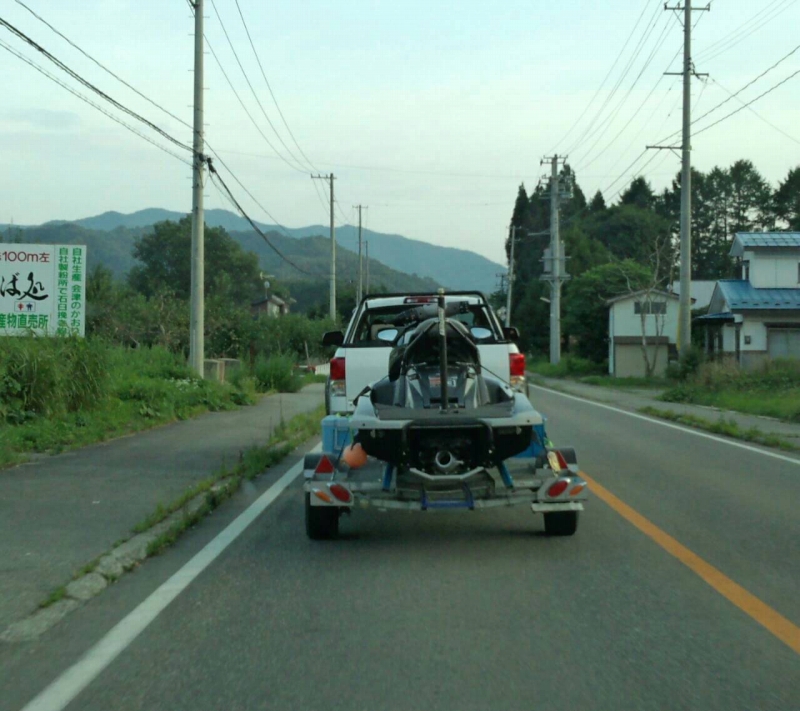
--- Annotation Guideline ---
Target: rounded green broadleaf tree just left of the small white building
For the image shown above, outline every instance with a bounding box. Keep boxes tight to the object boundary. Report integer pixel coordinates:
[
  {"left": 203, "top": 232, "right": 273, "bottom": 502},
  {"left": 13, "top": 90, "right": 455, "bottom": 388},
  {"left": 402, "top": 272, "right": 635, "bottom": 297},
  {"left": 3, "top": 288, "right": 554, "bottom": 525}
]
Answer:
[{"left": 564, "top": 259, "right": 653, "bottom": 363}]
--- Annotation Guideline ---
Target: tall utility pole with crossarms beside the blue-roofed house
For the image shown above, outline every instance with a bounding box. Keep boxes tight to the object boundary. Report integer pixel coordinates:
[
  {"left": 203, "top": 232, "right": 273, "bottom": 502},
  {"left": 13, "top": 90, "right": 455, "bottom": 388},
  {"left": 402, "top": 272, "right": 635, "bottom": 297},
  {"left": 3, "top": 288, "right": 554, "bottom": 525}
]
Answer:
[{"left": 647, "top": 0, "right": 711, "bottom": 354}]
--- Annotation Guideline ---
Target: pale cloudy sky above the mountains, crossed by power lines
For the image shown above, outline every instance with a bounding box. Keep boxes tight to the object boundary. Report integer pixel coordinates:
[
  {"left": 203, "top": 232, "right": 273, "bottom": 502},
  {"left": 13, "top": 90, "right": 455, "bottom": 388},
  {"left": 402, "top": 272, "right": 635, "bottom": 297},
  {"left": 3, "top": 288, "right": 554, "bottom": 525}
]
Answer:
[{"left": 0, "top": 0, "right": 800, "bottom": 263}]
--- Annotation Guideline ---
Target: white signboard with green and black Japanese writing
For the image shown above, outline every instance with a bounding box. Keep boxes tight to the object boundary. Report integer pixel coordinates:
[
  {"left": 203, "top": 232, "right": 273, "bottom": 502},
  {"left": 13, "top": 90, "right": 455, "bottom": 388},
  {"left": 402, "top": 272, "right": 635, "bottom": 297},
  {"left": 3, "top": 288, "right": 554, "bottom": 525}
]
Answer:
[{"left": 0, "top": 243, "right": 86, "bottom": 336}]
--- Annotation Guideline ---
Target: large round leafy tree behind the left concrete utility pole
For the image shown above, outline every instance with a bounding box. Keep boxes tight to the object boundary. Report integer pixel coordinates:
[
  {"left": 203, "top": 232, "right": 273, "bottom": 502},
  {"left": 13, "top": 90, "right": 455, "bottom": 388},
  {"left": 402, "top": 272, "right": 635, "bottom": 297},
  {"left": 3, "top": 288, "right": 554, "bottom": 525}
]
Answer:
[{"left": 128, "top": 216, "right": 264, "bottom": 305}]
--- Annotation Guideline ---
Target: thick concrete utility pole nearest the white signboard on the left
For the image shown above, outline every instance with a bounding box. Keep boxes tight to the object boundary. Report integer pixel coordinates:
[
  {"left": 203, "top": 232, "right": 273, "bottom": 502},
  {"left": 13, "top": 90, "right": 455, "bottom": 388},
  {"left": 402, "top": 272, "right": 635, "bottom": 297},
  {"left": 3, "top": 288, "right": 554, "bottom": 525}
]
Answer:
[{"left": 189, "top": 0, "right": 205, "bottom": 378}]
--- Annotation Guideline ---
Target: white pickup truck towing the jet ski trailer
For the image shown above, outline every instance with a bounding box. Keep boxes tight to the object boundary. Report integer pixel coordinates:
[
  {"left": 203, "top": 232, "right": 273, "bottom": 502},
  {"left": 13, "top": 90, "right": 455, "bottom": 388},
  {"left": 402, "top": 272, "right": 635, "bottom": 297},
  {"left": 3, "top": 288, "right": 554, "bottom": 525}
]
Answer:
[{"left": 323, "top": 291, "right": 527, "bottom": 414}]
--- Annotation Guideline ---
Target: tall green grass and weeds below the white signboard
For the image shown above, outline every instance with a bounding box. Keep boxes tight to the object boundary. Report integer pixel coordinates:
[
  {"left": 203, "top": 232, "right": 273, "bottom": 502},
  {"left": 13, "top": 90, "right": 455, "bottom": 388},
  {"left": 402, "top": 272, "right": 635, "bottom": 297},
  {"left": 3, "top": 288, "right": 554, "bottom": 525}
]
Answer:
[{"left": 0, "top": 339, "right": 257, "bottom": 467}]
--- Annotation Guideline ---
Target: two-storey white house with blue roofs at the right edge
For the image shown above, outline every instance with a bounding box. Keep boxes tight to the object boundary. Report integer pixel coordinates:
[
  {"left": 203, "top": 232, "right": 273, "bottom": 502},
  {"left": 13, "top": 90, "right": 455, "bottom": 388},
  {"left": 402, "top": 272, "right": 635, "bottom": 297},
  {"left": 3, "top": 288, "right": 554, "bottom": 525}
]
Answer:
[{"left": 695, "top": 232, "right": 800, "bottom": 368}]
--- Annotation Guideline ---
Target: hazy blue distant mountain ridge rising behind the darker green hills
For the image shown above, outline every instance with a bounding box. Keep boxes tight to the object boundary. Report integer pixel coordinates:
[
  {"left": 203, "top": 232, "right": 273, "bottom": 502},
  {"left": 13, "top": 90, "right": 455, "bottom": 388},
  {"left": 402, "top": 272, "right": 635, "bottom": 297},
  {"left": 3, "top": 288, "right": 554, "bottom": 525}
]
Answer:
[{"left": 9, "top": 208, "right": 505, "bottom": 293}]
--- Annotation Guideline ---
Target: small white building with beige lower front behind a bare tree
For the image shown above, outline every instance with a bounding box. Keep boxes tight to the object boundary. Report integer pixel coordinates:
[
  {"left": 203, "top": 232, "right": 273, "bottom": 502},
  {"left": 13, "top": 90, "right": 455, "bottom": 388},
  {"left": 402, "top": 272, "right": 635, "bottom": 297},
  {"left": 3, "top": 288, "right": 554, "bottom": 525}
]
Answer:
[{"left": 606, "top": 290, "right": 679, "bottom": 378}]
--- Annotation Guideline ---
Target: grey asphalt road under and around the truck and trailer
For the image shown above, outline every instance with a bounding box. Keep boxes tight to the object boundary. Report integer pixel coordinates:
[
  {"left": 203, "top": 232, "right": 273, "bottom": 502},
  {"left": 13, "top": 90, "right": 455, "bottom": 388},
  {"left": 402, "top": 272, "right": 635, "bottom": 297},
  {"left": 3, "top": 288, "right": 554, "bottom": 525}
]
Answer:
[{"left": 0, "top": 389, "right": 800, "bottom": 711}]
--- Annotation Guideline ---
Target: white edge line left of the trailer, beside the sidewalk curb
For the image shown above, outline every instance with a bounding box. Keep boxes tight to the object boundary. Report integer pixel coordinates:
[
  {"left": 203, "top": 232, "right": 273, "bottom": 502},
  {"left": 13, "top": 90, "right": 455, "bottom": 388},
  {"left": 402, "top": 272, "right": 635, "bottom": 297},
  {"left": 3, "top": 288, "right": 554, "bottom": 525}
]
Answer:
[{"left": 22, "top": 459, "right": 310, "bottom": 711}]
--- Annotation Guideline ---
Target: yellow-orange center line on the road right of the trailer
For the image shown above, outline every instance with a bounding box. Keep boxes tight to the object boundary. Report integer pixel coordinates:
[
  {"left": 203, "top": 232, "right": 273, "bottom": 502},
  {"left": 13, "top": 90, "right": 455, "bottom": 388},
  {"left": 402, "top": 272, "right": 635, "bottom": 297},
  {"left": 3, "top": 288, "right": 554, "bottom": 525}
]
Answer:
[{"left": 581, "top": 472, "right": 800, "bottom": 654}]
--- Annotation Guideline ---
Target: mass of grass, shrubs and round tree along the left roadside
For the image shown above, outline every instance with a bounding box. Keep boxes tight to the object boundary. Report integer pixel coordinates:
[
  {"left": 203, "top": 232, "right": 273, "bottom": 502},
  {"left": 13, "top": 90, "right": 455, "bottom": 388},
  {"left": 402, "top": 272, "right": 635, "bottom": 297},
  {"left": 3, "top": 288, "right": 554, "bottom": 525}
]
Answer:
[{"left": 0, "top": 220, "right": 333, "bottom": 467}]
